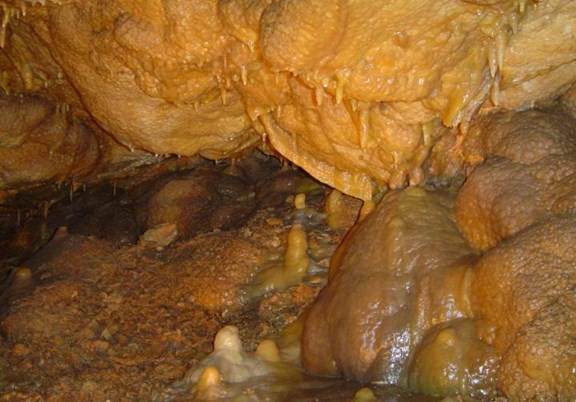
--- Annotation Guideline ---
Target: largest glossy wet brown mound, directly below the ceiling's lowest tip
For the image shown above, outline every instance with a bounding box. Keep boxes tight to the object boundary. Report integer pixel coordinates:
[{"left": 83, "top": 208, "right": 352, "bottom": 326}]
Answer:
[{"left": 302, "top": 188, "right": 475, "bottom": 384}]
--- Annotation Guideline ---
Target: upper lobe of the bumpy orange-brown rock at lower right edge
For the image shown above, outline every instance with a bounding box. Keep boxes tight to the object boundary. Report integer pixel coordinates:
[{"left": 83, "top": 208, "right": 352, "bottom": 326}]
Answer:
[{"left": 471, "top": 215, "right": 576, "bottom": 353}]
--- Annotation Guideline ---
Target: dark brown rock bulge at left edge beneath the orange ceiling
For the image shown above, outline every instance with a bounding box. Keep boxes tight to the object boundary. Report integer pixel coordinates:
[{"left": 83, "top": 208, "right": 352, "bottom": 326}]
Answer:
[{"left": 0, "top": 92, "right": 109, "bottom": 190}]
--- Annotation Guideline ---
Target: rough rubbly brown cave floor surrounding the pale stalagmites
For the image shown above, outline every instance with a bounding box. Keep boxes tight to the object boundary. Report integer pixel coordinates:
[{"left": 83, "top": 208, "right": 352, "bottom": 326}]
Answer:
[{"left": 0, "top": 159, "right": 433, "bottom": 401}]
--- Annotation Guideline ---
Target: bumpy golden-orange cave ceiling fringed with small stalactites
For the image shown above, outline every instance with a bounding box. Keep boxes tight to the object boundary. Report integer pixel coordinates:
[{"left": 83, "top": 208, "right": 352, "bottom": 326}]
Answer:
[{"left": 0, "top": 0, "right": 576, "bottom": 199}]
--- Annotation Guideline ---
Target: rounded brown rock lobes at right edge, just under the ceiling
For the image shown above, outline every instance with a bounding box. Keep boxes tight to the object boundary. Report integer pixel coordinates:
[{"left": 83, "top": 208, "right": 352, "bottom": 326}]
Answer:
[{"left": 455, "top": 104, "right": 576, "bottom": 250}]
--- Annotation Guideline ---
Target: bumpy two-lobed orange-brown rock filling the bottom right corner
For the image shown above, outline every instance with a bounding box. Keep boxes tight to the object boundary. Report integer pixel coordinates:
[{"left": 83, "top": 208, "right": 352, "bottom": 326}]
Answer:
[{"left": 472, "top": 215, "right": 576, "bottom": 401}]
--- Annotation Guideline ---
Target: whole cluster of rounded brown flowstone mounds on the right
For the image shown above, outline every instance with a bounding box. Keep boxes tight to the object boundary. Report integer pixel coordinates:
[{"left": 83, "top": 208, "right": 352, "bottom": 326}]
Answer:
[{"left": 302, "top": 104, "right": 576, "bottom": 401}]
